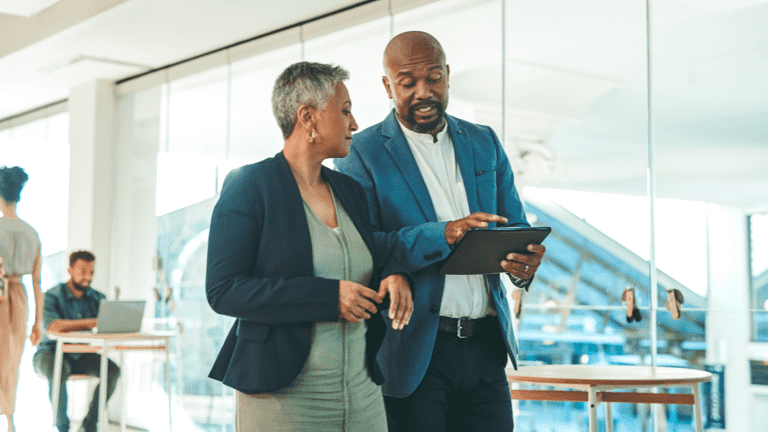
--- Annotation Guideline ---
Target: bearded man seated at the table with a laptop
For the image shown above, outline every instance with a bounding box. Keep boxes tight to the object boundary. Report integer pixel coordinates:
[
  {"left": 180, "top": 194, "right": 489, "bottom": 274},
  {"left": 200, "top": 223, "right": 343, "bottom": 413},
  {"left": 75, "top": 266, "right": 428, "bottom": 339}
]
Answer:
[{"left": 32, "top": 251, "right": 120, "bottom": 432}]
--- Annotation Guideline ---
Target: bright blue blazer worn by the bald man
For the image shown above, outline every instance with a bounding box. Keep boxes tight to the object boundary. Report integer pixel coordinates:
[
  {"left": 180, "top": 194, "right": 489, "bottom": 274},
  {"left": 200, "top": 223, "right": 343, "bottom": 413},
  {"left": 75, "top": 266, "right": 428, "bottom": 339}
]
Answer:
[{"left": 335, "top": 110, "right": 529, "bottom": 397}]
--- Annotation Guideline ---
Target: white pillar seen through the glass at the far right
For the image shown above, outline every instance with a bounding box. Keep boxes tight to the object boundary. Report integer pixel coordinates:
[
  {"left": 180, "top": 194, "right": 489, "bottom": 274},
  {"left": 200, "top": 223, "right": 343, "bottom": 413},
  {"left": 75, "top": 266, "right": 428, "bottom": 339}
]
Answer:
[{"left": 707, "top": 204, "right": 753, "bottom": 432}]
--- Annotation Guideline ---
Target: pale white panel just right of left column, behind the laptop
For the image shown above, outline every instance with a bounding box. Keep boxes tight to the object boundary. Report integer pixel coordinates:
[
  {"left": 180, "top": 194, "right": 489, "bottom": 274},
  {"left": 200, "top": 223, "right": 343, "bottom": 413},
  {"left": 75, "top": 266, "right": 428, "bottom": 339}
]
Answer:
[{"left": 110, "top": 85, "right": 163, "bottom": 429}]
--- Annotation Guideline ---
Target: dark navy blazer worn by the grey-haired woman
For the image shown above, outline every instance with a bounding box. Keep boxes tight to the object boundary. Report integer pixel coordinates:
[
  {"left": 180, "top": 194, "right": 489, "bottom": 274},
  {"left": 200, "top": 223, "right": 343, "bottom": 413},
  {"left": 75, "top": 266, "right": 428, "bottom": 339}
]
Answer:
[{"left": 205, "top": 153, "right": 399, "bottom": 394}]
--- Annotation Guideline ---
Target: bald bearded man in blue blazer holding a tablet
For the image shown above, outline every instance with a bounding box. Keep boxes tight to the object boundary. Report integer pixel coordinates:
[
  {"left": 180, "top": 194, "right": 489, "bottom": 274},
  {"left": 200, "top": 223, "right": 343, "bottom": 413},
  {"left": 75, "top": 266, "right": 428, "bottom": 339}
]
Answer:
[{"left": 336, "top": 32, "right": 544, "bottom": 432}]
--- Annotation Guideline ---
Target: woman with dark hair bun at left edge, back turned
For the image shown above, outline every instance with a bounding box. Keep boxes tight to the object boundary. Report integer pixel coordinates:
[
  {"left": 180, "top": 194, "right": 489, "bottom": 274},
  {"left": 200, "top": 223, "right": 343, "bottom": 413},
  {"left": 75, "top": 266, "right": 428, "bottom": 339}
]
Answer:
[{"left": 0, "top": 166, "right": 43, "bottom": 432}]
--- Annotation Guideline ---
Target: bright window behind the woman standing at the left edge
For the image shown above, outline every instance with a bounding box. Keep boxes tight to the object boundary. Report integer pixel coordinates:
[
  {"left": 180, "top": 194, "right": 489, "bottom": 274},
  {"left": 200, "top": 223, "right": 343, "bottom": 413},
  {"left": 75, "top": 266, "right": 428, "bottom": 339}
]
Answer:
[{"left": 0, "top": 103, "right": 70, "bottom": 431}]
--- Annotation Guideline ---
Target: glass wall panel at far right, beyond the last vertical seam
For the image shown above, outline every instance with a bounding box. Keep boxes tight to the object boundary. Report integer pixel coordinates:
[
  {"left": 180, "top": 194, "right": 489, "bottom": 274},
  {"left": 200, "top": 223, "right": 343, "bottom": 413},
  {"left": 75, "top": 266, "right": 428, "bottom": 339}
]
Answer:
[{"left": 649, "top": 0, "right": 768, "bottom": 431}]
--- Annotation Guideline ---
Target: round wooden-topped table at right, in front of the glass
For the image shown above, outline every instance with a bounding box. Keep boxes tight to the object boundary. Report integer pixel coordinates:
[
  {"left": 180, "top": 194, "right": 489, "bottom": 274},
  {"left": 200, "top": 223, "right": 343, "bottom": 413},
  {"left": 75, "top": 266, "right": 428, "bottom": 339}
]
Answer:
[{"left": 507, "top": 365, "right": 712, "bottom": 432}]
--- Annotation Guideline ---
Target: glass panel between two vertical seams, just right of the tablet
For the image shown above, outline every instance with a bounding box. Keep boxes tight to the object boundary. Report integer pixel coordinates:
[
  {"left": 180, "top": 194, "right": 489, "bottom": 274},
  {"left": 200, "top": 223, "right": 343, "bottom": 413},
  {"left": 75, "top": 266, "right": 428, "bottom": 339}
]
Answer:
[{"left": 504, "top": 0, "right": 656, "bottom": 431}]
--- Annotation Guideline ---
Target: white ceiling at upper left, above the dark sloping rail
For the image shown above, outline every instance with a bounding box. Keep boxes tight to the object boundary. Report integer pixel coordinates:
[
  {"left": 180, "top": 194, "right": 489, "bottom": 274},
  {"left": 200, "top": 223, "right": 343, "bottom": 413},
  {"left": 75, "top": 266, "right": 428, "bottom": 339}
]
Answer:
[{"left": 0, "top": 0, "right": 360, "bottom": 119}]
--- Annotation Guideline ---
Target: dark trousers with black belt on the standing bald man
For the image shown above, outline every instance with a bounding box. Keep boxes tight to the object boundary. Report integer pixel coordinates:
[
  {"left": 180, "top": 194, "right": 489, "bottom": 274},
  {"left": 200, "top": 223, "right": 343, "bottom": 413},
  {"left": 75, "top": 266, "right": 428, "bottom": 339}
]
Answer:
[{"left": 384, "top": 317, "right": 513, "bottom": 432}]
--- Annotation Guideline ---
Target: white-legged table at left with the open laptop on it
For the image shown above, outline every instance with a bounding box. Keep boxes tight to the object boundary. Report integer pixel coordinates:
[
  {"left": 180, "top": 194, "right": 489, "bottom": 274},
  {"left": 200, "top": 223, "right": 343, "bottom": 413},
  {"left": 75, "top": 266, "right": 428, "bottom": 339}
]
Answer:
[{"left": 48, "top": 332, "right": 175, "bottom": 432}]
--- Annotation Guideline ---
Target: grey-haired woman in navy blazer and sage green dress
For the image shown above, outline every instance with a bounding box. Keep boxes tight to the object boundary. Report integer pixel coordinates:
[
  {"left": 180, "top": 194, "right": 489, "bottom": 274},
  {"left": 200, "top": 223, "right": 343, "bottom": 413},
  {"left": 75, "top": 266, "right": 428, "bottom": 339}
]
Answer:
[{"left": 206, "top": 62, "right": 413, "bottom": 432}]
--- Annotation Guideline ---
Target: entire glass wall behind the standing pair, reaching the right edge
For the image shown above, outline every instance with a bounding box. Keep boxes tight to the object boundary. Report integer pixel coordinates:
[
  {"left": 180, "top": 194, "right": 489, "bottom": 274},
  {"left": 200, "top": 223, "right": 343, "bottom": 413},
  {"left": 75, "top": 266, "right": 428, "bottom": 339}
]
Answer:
[{"left": 108, "top": 0, "right": 768, "bottom": 431}]
